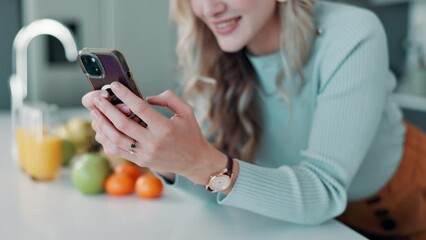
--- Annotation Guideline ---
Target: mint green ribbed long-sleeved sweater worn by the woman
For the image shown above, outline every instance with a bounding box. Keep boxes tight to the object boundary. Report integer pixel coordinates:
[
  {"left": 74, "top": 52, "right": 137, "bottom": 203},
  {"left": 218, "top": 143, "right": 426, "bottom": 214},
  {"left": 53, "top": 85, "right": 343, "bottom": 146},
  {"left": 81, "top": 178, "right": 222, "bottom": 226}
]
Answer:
[{"left": 168, "top": 2, "right": 405, "bottom": 224}]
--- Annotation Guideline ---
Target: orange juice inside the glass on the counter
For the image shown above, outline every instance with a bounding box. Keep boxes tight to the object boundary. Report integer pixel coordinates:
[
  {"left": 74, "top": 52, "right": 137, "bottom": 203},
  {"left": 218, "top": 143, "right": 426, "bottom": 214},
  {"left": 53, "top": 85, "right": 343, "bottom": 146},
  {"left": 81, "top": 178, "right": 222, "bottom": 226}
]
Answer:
[{"left": 17, "top": 128, "right": 62, "bottom": 181}]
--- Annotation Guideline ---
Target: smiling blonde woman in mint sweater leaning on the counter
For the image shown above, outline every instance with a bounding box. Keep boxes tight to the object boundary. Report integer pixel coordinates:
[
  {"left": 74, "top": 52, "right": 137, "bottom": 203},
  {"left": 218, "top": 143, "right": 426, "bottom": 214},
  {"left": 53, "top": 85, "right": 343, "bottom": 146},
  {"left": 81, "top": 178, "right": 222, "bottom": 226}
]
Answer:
[{"left": 82, "top": 0, "right": 426, "bottom": 239}]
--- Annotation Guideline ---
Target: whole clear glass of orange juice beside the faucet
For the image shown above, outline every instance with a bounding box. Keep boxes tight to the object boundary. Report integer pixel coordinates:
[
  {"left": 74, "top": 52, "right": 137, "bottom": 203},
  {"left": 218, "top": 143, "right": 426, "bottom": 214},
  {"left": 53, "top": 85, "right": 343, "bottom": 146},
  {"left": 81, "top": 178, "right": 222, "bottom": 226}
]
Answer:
[{"left": 15, "top": 104, "right": 62, "bottom": 181}]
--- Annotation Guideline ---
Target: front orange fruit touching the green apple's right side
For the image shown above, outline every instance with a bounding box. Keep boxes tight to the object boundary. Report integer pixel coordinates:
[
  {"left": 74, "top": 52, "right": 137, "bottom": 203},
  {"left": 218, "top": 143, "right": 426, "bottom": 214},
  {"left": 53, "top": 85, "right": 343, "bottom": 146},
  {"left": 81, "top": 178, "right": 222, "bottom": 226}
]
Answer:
[{"left": 105, "top": 173, "right": 135, "bottom": 196}]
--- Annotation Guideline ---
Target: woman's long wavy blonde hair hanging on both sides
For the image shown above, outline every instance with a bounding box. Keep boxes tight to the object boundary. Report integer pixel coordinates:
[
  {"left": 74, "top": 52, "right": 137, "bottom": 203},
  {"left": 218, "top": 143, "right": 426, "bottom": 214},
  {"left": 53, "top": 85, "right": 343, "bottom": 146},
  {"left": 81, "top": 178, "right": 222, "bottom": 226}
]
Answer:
[{"left": 170, "top": 0, "right": 316, "bottom": 162}]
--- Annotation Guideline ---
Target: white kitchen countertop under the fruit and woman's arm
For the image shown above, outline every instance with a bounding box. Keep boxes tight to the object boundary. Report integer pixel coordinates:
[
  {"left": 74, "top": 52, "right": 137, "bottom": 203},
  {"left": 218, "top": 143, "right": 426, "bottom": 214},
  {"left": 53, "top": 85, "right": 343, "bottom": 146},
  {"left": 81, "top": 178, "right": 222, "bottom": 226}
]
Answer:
[{"left": 0, "top": 112, "right": 365, "bottom": 240}]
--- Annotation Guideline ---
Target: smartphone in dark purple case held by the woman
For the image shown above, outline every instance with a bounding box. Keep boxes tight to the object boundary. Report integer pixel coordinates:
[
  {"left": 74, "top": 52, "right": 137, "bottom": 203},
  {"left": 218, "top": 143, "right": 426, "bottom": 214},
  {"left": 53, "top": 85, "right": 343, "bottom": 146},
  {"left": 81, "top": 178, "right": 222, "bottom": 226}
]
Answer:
[{"left": 78, "top": 48, "right": 146, "bottom": 126}]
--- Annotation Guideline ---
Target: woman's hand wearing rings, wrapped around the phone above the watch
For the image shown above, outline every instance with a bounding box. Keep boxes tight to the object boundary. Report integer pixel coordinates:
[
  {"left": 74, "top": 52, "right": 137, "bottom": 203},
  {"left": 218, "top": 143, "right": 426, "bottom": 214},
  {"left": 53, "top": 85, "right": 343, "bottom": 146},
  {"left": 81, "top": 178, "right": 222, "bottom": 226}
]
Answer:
[{"left": 91, "top": 82, "right": 226, "bottom": 184}]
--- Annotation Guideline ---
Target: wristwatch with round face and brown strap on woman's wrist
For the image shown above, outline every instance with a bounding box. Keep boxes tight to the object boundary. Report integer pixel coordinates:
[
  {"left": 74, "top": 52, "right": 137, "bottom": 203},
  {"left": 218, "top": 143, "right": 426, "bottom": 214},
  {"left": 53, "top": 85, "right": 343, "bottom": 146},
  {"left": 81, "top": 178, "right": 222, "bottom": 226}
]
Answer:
[{"left": 206, "top": 156, "right": 234, "bottom": 193}]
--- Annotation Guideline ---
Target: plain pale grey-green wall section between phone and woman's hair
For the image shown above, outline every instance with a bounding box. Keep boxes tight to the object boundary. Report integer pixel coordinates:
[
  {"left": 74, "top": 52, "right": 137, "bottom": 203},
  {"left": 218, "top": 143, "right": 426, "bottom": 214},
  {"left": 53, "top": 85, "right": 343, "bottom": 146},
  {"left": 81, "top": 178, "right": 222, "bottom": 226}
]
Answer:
[{"left": 113, "top": 0, "right": 176, "bottom": 96}]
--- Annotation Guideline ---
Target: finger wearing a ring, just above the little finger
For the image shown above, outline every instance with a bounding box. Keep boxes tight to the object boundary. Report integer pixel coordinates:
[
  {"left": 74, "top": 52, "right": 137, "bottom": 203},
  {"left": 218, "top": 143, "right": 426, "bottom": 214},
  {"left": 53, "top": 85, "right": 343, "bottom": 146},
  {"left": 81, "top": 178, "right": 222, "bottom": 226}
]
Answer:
[{"left": 90, "top": 109, "right": 139, "bottom": 152}]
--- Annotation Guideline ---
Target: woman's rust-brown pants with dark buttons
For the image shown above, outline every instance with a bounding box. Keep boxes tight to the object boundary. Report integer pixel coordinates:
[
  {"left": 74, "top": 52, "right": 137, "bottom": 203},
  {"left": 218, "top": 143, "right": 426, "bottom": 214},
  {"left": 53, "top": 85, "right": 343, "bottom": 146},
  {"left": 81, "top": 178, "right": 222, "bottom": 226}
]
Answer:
[{"left": 338, "top": 124, "right": 426, "bottom": 240}]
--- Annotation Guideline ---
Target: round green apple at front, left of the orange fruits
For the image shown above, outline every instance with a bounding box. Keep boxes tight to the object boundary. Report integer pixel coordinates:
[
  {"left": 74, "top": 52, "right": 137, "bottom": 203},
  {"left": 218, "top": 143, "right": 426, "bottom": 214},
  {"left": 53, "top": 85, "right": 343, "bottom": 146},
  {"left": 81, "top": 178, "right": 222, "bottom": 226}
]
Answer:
[{"left": 71, "top": 153, "right": 111, "bottom": 194}]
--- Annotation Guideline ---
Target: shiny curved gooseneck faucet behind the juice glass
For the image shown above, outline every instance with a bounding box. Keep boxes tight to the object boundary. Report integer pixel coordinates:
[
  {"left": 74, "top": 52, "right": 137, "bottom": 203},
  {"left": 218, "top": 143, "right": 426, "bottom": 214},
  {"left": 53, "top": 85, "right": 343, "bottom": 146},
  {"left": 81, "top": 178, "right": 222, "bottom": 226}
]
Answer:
[{"left": 9, "top": 19, "right": 77, "bottom": 159}]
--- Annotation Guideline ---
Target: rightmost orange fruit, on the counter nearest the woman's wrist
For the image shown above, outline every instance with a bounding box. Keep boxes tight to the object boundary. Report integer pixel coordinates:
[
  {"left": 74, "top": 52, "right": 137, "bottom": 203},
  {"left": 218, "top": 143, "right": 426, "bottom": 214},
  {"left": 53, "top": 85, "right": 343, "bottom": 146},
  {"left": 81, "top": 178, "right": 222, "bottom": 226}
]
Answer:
[{"left": 135, "top": 173, "right": 163, "bottom": 198}]
